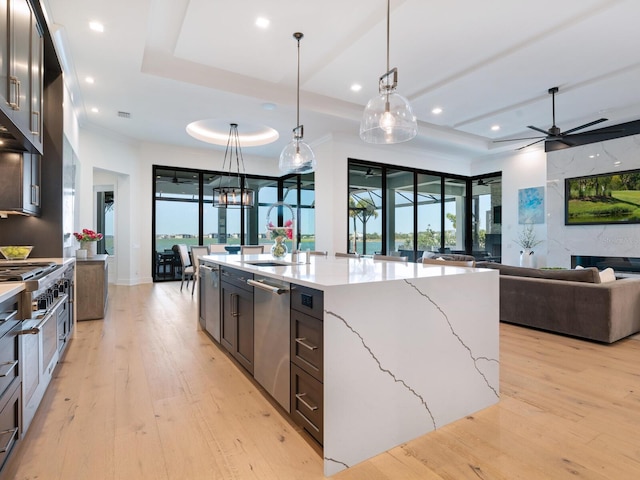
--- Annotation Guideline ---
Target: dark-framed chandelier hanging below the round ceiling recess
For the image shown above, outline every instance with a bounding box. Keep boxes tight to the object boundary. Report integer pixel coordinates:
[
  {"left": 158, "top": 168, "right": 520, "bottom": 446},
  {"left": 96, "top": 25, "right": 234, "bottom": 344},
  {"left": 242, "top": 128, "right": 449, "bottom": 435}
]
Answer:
[{"left": 213, "top": 123, "right": 256, "bottom": 208}]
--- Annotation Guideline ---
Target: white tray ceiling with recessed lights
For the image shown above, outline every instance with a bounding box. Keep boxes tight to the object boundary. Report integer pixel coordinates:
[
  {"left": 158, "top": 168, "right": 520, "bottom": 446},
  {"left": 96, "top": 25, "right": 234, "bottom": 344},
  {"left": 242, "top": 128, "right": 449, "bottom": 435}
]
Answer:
[{"left": 42, "top": 0, "right": 640, "bottom": 158}]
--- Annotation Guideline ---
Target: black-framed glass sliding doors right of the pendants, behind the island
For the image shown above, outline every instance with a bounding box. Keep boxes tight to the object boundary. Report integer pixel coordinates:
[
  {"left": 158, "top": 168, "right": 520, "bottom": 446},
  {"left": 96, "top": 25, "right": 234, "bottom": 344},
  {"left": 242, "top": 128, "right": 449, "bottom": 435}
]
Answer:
[{"left": 347, "top": 160, "right": 502, "bottom": 261}]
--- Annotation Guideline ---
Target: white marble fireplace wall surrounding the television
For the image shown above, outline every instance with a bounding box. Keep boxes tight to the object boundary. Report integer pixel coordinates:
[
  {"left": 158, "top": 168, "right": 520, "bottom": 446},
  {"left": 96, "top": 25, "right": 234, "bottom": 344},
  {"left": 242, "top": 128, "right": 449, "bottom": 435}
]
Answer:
[{"left": 546, "top": 135, "right": 640, "bottom": 270}]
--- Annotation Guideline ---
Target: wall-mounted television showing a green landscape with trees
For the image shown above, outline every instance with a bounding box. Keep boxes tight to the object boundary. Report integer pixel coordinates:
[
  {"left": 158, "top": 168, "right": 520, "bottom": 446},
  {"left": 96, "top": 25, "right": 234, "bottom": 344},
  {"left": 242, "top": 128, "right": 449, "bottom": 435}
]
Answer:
[{"left": 564, "top": 169, "right": 640, "bottom": 225}]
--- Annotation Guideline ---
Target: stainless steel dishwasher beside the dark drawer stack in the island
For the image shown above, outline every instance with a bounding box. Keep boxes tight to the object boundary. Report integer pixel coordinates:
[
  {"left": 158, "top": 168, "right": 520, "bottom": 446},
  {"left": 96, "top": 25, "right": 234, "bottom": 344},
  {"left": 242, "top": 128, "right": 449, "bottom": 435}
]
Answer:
[{"left": 247, "top": 275, "right": 291, "bottom": 412}]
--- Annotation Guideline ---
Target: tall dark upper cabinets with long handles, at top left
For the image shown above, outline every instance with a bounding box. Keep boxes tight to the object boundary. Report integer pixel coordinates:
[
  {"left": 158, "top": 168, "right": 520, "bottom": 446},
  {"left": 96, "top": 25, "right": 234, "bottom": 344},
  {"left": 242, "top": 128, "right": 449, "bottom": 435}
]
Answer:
[{"left": 0, "top": 0, "right": 44, "bottom": 153}]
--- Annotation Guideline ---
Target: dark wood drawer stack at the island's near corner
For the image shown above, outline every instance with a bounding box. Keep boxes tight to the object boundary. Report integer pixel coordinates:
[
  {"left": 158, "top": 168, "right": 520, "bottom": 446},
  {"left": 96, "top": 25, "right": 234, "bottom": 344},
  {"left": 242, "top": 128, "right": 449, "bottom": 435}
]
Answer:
[{"left": 291, "top": 285, "right": 324, "bottom": 444}]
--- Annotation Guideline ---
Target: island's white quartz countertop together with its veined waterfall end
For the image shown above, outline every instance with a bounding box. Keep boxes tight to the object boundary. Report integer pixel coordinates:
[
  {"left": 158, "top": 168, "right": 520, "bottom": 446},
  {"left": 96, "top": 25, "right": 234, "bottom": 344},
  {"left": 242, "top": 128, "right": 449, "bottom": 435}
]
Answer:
[{"left": 202, "top": 255, "right": 499, "bottom": 475}]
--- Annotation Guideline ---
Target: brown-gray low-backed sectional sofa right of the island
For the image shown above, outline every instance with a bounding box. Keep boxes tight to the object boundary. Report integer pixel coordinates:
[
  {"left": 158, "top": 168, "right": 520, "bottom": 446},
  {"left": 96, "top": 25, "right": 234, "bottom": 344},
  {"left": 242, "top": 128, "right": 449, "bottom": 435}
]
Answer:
[{"left": 477, "top": 262, "right": 640, "bottom": 343}]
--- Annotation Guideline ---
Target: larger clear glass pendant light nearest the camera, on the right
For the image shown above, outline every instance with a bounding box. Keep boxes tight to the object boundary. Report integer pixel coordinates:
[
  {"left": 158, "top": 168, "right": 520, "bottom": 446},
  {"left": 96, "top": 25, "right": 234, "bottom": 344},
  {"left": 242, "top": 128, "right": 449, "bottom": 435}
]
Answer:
[{"left": 360, "top": 0, "right": 418, "bottom": 143}]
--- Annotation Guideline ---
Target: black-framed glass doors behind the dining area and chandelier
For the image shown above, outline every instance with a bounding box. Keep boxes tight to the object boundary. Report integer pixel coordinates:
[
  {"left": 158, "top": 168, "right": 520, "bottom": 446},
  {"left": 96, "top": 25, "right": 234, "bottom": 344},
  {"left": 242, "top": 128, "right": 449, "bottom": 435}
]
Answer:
[{"left": 153, "top": 166, "right": 315, "bottom": 281}]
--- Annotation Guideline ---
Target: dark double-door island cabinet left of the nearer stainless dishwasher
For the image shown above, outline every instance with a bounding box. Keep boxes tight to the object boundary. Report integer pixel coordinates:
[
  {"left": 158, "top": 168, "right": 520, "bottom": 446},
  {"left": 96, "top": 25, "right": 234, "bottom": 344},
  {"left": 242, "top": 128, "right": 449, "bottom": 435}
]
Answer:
[{"left": 220, "top": 267, "right": 253, "bottom": 375}]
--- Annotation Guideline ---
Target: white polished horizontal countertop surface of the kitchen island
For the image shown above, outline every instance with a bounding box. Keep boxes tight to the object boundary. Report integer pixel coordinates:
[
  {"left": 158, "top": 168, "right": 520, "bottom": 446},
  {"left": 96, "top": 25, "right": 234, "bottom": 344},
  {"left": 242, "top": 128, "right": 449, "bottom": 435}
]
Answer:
[{"left": 202, "top": 254, "right": 497, "bottom": 289}]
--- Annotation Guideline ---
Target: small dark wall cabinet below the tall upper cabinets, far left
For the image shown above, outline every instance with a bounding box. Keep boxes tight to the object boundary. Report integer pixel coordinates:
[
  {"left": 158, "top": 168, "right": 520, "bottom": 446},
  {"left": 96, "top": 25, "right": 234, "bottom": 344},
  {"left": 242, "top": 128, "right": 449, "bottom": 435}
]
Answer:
[{"left": 0, "top": 152, "right": 40, "bottom": 216}]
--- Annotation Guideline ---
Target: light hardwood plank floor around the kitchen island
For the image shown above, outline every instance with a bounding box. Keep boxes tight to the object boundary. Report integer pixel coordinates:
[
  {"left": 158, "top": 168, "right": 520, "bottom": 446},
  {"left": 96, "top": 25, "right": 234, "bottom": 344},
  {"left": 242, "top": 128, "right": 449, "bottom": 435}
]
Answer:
[{"left": 3, "top": 283, "right": 640, "bottom": 480}]
